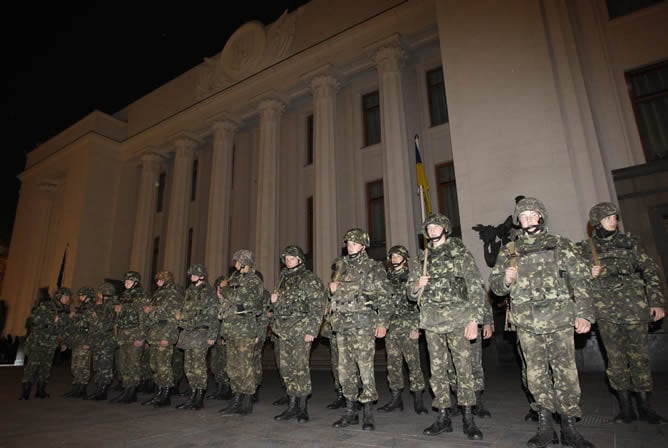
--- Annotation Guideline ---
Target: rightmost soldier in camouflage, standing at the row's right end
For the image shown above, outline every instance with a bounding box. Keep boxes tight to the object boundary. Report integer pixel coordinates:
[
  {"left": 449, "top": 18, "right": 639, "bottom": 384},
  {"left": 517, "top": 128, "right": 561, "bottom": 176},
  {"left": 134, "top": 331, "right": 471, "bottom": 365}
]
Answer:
[{"left": 580, "top": 202, "right": 666, "bottom": 424}]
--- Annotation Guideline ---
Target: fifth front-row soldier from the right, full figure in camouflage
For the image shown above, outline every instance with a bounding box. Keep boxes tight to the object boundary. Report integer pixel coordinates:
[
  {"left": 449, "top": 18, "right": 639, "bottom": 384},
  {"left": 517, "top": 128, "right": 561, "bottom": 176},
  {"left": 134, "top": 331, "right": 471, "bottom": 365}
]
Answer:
[{"left": 271, "top": 246, "right": 326, "bottom": 422}]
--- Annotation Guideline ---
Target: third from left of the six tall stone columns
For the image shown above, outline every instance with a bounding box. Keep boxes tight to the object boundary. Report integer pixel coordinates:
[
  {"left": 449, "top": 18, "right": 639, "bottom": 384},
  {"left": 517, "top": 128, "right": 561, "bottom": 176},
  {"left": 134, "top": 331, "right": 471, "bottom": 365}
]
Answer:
[{"left": 204, "top": 120, "right": 238, "bottom": 278}]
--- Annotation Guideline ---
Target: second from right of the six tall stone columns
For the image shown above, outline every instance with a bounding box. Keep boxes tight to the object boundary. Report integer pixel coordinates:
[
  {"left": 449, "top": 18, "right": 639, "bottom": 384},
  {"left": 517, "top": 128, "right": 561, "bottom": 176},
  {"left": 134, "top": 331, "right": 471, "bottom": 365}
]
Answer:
[{"left": 311, "top": 76, "right": 339, "bottom": 279}]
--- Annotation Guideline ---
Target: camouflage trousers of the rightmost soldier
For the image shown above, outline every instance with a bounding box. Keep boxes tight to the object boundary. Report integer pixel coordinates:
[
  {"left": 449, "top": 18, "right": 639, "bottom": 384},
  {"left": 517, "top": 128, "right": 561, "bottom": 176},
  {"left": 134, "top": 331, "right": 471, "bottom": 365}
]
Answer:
[{"left": 597, "top": 320, "right": 652, "bottom": 392}]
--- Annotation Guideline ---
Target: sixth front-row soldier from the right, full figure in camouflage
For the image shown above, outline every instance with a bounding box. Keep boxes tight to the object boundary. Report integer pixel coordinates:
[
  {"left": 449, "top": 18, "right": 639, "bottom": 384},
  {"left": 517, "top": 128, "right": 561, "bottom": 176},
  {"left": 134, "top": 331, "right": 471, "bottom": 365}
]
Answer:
[{"left": 219, "top": 249, "right": 266, "bottom": 415}]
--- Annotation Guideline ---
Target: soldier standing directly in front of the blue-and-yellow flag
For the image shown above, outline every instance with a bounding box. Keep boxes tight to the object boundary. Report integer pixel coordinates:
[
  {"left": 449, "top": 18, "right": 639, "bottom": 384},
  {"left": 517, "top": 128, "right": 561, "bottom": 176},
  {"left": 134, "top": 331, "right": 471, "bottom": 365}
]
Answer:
[{"left": 406, "top": 213, "right": 487, "bottom": 440}]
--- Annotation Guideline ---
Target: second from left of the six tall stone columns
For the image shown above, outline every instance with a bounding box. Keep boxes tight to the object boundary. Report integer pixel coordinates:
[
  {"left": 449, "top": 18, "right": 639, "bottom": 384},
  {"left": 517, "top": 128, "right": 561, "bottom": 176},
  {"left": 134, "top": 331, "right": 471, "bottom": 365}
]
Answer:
[{"left": 165, "top": 137, "right": 197, "bottom": 282}]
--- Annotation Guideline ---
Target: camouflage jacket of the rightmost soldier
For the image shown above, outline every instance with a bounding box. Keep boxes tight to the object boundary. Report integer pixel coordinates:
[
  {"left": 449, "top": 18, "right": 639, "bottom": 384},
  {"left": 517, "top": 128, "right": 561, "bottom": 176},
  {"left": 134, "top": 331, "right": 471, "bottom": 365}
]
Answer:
[{"left": 578, "top": 232, "right": 666, "bottom": 323}]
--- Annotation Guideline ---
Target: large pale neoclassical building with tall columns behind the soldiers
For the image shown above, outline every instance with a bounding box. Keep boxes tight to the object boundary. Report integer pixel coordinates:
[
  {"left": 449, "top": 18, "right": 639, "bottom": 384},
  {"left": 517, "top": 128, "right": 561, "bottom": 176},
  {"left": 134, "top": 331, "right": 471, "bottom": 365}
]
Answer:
[{"left": 2, "top": 0, "right": 668, "bottom": 335}]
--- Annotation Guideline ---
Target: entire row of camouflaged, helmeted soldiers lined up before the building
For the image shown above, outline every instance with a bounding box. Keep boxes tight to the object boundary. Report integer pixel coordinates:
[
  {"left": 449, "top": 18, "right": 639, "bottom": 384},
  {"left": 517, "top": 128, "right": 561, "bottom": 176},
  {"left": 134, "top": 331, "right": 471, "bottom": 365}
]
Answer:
[{"left": 21, "top": 198, "right": 666, "bottom": 448}]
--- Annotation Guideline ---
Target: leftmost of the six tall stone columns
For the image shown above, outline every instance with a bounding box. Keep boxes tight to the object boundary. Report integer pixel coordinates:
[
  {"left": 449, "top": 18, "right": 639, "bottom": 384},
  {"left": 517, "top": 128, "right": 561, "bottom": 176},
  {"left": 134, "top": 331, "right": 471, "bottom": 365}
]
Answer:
[{"left": 130, "top": 153, "right": 160, "bottom": 274}]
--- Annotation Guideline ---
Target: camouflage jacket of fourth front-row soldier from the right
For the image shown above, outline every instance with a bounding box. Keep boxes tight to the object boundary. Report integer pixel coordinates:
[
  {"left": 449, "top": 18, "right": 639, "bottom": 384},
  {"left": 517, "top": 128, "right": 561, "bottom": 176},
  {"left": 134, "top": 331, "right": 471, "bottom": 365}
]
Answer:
[{"left": 328, "top": 251, "right": 394, "bottom": 332}]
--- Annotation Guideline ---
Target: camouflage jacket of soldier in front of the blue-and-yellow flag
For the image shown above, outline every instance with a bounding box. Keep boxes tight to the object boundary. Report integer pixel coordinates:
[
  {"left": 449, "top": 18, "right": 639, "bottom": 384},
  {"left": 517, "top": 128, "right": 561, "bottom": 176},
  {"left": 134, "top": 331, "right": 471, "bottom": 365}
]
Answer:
[{"left": 406, "top": 237, "right": 487, "bottom": 333}]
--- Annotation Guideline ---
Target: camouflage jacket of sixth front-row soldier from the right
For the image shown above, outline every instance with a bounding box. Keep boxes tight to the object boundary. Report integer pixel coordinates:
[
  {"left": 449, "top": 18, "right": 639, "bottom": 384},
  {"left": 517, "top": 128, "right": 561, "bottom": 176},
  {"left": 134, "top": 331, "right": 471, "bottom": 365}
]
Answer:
[{"left": 218, "top": 268, "right": 268, "bottom": 339}]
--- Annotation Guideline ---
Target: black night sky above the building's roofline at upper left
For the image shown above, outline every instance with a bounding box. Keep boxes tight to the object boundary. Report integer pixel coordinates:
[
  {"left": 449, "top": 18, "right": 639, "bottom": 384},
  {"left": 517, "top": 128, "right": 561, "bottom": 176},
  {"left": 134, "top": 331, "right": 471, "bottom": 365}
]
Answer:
[{"left": 0, "top": 0, "right": 307, "bottom": 244}]
